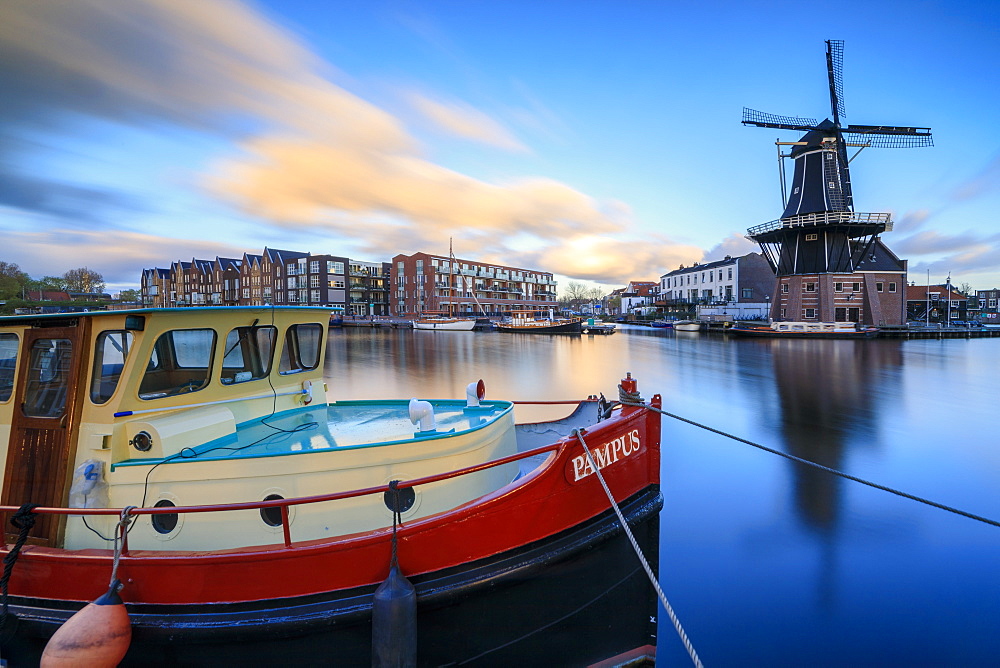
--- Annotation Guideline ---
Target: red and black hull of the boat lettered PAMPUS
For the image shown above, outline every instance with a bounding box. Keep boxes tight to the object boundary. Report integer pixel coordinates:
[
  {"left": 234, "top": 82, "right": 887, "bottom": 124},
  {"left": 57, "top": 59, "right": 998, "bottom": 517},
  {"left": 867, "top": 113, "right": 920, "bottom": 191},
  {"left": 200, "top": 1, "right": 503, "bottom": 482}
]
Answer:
[{"left": 3, "top": 396, "right": 662, "bottom": 665}]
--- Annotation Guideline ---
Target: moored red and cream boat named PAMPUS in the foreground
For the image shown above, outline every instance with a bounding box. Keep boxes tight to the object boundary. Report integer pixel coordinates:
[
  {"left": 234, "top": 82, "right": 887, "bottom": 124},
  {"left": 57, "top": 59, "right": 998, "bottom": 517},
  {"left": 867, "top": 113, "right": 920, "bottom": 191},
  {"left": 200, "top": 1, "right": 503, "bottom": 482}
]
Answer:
[{"left": 0, "top": 306, "right": 663, "bottom": 666}]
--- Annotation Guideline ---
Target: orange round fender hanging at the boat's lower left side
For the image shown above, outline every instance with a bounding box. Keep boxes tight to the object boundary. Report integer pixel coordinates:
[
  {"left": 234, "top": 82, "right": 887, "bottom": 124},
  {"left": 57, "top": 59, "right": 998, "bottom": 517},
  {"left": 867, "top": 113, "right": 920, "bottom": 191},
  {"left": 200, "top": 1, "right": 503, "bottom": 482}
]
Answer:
[{"left": 41, "top": 579, "right": 132, "bottom": 668}]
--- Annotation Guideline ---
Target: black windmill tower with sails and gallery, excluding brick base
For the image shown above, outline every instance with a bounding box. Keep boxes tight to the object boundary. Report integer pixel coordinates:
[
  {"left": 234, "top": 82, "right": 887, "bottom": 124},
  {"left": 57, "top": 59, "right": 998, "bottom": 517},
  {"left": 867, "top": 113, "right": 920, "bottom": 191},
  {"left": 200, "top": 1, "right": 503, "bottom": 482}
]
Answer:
[{"left": 743, "top": 40, "right": 933, "bottom": 281}]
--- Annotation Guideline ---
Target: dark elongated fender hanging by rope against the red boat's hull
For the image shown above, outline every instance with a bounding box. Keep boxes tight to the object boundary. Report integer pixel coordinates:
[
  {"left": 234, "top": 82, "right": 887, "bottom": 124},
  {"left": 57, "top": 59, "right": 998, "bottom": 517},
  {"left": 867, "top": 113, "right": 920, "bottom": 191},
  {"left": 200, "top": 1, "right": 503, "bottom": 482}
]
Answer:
[{"left": 372, "top": 480, "right": 417, "bottom": 668}]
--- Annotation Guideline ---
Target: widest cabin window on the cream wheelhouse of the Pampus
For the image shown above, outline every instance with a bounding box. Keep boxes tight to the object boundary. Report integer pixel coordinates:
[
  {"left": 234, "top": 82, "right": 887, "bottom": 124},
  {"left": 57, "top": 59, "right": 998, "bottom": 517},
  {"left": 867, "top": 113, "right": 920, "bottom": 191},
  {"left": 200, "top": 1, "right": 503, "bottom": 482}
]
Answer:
[{"left": 139, "top": 329, "right": 215, "bottom": 399}]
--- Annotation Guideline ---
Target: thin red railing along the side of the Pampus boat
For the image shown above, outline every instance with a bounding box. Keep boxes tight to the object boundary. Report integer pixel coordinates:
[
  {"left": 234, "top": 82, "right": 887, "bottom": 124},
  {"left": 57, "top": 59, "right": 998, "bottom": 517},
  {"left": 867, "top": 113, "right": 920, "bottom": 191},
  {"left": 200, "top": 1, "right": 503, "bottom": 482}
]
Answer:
[{"left": 0, "top": 399, "right": 608, "bottom": 556}]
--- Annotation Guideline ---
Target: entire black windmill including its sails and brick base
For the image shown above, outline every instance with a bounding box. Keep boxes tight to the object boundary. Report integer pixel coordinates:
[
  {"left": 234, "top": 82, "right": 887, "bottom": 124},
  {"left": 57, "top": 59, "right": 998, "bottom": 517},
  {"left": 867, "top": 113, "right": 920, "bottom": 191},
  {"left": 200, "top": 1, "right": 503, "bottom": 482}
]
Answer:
[{"left": 743, "top": 40, "right": 933, "bottom": 325}]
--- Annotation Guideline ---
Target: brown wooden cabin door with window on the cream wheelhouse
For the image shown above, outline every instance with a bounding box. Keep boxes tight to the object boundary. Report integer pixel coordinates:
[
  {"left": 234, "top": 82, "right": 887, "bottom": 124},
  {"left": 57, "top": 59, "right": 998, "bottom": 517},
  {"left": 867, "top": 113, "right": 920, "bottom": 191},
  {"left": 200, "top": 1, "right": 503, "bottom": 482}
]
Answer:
[{"left": 0, "top": 318, "right": 86, "bottom": 545}]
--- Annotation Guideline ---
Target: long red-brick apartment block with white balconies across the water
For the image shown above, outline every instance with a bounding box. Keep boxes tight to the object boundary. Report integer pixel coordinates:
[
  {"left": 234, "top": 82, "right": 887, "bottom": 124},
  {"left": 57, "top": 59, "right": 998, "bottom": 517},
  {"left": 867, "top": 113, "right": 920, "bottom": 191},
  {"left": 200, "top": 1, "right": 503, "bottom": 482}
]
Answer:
[{"left": 390, "top": 253, "right": 556, "bottom": 317}]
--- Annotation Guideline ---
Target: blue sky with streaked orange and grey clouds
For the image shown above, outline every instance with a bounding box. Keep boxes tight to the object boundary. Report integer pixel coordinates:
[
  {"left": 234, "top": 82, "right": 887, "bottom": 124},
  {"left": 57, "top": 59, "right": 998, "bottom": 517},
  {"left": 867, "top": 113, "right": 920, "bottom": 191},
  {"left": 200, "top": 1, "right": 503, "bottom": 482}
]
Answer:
[{"left": 0, "top": 0, "right": 1000, "bottom": 291}]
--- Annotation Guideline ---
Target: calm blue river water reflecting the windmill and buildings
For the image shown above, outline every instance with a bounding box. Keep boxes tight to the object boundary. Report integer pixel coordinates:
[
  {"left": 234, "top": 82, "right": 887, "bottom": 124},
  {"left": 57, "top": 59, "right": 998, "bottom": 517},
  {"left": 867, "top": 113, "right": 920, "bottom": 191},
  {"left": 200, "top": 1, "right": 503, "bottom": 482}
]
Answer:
[{"left": 326, "top": 327, "right": 1000, "bottom": 666}]
